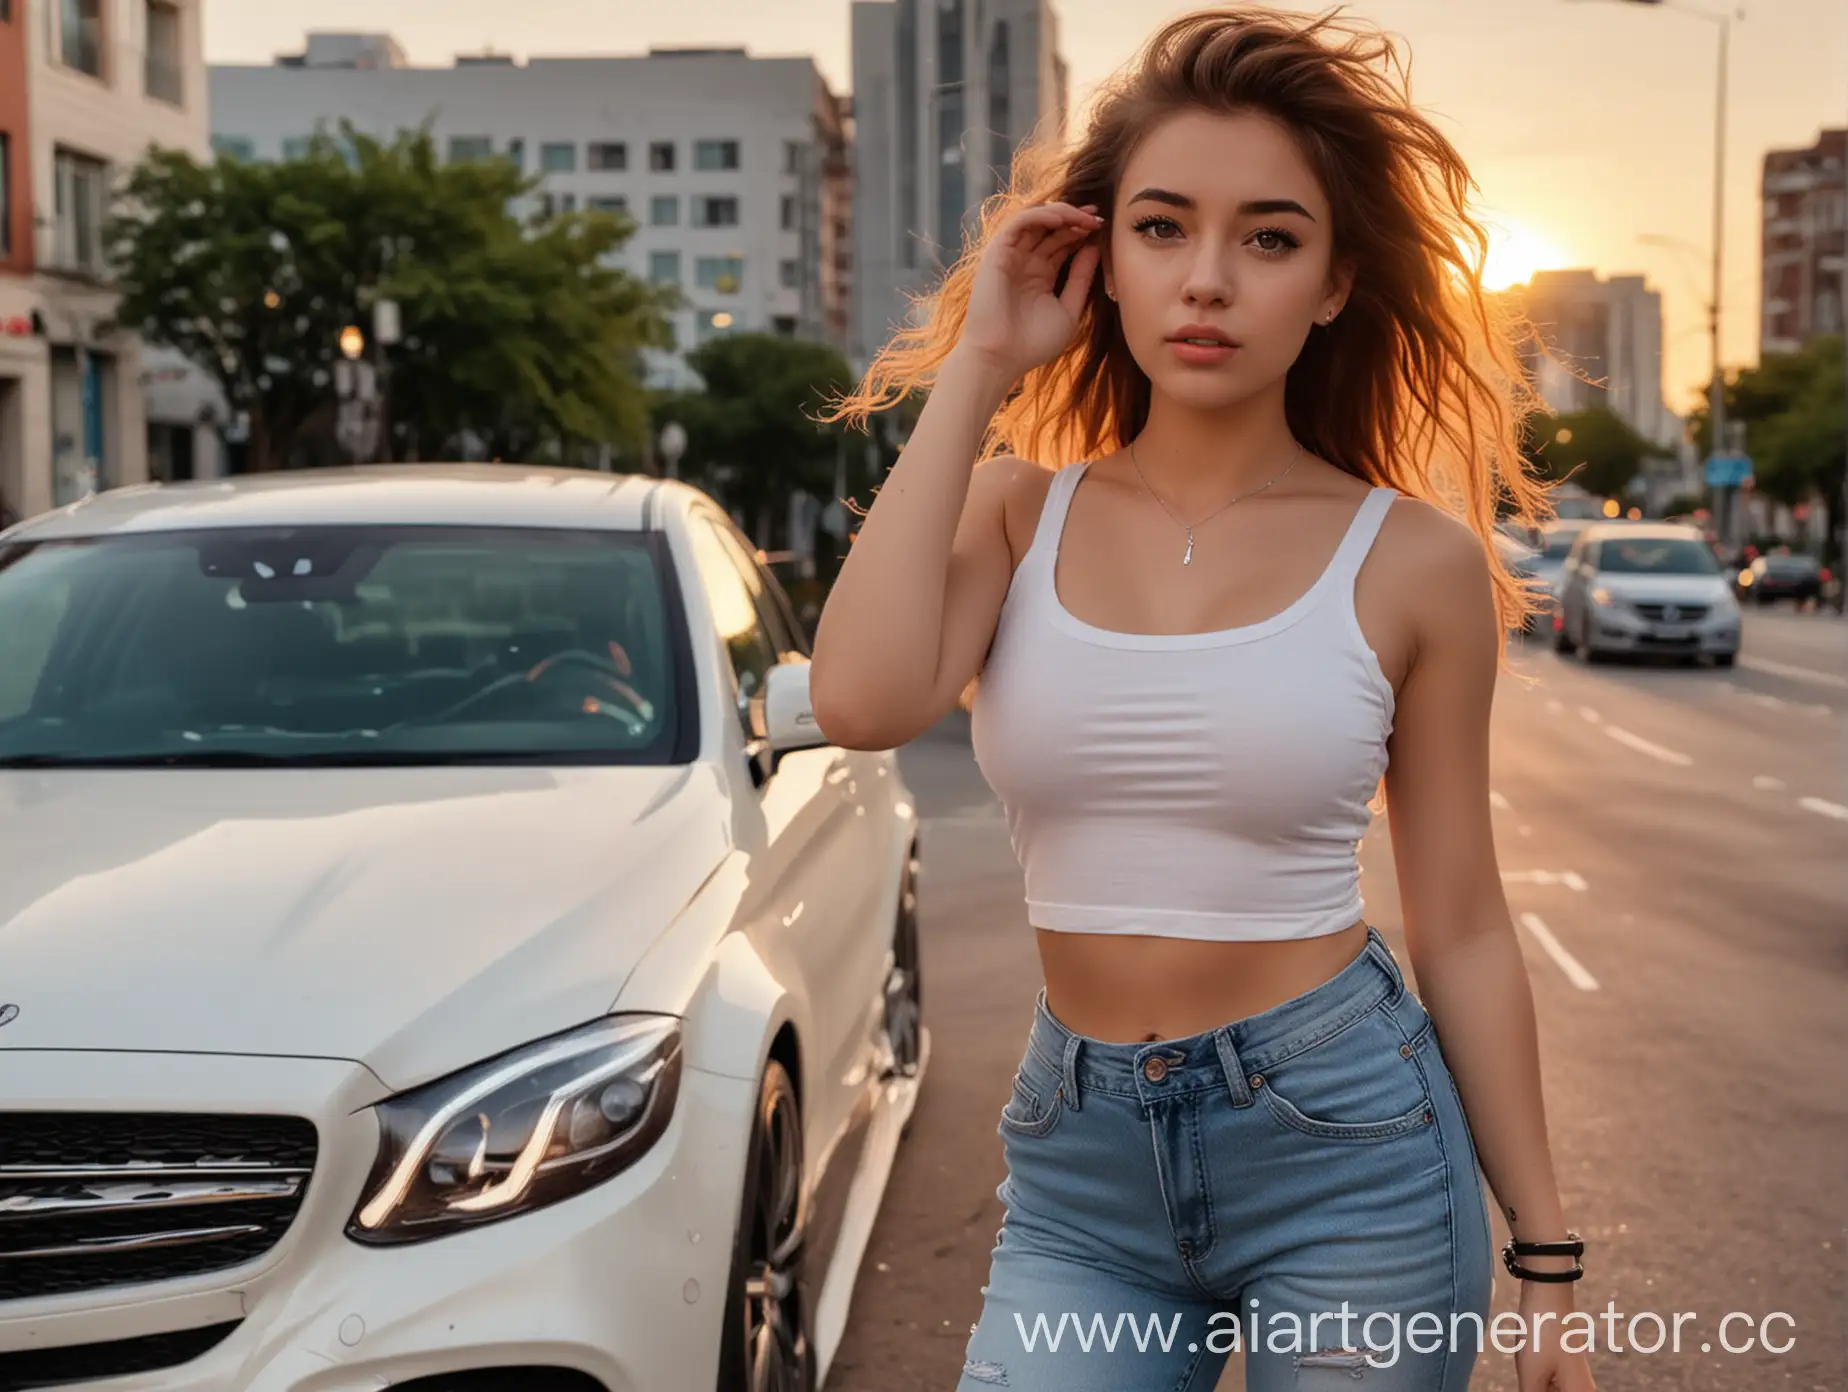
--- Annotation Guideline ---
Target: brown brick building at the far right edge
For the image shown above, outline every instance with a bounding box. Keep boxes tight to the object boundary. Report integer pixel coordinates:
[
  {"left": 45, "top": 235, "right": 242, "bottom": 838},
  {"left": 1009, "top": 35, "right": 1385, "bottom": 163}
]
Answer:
[{"left": 1757, "top": 129, "right": 1848, "bottom": 357}]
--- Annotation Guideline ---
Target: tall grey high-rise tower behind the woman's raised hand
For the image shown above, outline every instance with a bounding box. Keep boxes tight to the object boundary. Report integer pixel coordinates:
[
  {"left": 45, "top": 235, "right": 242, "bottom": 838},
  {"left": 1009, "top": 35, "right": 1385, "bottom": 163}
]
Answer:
[{"left": 852, "top": 0, "right": 1070, "bottom": 366}]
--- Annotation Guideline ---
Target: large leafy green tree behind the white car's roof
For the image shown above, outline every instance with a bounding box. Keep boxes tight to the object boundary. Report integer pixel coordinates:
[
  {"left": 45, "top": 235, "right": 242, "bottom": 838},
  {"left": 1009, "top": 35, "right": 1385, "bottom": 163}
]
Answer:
[{"left": 107, "top": 126, "right": 669, "bottom": 470}]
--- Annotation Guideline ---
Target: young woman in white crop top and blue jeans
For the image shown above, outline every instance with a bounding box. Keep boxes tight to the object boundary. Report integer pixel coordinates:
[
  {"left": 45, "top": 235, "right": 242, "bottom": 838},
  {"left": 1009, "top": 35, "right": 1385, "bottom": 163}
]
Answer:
[{"left": 811, "top": 9, "right": 1593, "bottom": 1392}]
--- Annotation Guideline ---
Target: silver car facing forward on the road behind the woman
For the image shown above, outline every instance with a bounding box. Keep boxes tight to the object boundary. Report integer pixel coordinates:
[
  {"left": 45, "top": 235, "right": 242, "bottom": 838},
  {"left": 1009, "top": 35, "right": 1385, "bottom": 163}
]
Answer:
[{"left": 1554, "top": 521, "right": 1739, "bottom": 667}]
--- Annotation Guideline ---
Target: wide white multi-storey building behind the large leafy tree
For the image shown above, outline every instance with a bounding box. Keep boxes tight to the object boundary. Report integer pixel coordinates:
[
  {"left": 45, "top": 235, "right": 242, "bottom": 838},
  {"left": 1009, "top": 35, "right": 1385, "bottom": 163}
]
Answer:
[{"left": 211, "top": 33, "right": 852, "bottom": 386}]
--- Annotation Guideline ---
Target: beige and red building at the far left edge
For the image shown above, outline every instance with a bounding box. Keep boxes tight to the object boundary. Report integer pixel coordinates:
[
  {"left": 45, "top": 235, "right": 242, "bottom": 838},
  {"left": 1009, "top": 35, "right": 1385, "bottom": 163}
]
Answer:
[{"left": 0, "top": 0, "right": 218, "bottom": 516}]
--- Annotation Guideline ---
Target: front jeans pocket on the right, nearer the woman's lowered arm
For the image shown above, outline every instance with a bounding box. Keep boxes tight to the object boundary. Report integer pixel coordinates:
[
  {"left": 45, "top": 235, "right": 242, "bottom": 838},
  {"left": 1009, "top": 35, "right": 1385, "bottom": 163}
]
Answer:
[{"left": 1251, "top": 1009, "right": 1436, "bottom": 1141}]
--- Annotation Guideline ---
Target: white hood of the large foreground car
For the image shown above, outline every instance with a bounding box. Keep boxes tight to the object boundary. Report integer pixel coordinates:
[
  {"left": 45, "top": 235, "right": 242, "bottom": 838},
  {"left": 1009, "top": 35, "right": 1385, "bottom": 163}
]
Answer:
[{"left": 0, "top": 765, "right": 728, "bottom": 1087}]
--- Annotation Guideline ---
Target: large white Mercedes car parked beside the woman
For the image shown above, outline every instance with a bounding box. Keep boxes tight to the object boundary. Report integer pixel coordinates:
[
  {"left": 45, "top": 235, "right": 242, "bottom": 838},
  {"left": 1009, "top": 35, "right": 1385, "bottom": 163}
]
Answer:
[{"left": 0, "top": 466, "right": 930, "bottom": 1392}]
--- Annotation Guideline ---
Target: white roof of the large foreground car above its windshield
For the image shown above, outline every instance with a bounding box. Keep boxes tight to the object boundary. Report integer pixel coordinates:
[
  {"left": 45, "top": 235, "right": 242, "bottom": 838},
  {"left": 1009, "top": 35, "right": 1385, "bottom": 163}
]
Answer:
[{"left": 6, "top": 464, "right": 680, "bottom": 542}]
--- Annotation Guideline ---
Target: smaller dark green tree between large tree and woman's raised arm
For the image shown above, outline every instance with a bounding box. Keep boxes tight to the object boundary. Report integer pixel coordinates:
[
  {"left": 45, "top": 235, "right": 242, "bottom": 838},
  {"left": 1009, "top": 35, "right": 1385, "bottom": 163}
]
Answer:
[{"left": 654, "top": 333, "right": 863, "bottom": 545}]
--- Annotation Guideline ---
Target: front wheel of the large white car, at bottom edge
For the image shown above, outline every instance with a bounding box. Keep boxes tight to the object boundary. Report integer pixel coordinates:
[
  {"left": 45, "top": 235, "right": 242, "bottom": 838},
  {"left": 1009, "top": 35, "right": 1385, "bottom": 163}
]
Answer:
[{"left": 717, "top": 1059, "right": 815, "bottom": 1392}]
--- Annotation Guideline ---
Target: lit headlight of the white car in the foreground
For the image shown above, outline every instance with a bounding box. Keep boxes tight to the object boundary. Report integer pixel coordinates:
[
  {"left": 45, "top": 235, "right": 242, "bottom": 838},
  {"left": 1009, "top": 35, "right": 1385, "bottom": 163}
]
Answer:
[{"left": 347, "top": 1015, "right": 680, "bottom": 1244}]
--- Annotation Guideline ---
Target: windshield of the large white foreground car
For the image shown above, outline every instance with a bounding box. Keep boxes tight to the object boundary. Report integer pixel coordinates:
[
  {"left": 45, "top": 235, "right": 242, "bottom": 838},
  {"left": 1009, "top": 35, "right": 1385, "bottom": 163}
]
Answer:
[{"left": 0, "top": 527, "right": 687, "bottom": 767}]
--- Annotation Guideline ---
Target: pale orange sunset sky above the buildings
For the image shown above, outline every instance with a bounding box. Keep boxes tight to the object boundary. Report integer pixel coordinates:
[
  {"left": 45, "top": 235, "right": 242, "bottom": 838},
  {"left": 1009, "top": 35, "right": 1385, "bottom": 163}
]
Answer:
[{"left": 205, "top": 0, "right": 1848, "bottom": 410}]
